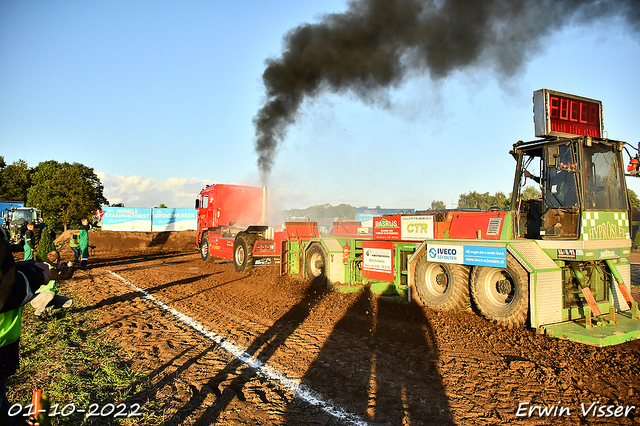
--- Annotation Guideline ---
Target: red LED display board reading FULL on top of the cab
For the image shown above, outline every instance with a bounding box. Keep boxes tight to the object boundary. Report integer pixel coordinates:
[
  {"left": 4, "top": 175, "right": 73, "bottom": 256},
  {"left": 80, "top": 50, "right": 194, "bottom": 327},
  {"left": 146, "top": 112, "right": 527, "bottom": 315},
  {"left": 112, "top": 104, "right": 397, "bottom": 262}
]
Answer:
[{"left": 533, "top": 89, "right": 602, "bottom": 137}]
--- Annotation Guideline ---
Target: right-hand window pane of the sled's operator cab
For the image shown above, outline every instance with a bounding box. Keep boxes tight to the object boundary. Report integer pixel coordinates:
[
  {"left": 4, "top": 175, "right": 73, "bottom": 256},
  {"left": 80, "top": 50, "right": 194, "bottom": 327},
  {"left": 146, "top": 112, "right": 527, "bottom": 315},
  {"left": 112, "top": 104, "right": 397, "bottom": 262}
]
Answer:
[{"left": 584, "top": 144, "right": 627, "bottom": 211}]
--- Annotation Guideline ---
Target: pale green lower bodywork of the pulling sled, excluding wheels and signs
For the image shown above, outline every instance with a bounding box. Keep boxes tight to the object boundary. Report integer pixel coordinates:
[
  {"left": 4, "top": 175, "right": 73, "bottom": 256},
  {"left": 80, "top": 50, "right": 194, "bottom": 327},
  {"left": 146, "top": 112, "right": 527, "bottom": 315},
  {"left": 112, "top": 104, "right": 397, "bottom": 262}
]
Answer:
[{"left": 287, "top": 216, "right": 640, "bottom": 346}]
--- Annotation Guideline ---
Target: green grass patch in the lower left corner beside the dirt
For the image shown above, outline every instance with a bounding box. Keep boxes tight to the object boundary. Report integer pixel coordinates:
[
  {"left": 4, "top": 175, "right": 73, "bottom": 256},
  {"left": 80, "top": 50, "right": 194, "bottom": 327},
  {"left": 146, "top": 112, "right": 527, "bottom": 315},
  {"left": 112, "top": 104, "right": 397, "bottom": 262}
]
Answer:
[{"left": 7, "top": 295, "right": 168, "bottom": 425}]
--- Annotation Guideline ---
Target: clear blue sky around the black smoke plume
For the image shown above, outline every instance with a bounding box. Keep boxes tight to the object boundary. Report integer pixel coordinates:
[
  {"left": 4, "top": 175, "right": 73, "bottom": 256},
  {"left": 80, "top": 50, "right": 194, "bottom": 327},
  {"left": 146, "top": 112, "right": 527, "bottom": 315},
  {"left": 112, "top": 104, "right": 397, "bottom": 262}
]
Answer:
[{"left": 0, "top": 0, "right": 640, "bottom": 209}]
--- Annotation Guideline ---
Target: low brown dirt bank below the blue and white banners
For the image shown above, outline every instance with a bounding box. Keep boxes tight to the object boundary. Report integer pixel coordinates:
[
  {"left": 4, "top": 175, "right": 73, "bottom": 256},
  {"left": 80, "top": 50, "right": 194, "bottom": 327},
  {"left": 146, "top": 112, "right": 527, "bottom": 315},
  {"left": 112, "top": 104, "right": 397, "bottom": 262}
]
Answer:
[{"left": 55, "top": 229, "right": 196, "bottom": 251}]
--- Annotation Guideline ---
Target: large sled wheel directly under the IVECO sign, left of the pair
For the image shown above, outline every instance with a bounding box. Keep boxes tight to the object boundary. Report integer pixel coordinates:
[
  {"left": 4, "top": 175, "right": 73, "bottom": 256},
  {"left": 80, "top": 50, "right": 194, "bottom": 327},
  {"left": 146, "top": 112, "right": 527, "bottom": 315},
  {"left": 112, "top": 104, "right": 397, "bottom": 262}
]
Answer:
[{"left": 414, "top": 253, "right": 471, "bottom": 311}]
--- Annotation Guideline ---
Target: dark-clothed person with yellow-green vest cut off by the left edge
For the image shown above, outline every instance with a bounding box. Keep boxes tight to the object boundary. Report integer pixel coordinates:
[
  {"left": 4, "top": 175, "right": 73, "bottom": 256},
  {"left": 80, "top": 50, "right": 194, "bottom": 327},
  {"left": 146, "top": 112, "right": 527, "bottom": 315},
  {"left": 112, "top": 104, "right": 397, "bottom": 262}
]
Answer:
[{"left": 0, "top": 231, "right": 50, "bottom": 425}]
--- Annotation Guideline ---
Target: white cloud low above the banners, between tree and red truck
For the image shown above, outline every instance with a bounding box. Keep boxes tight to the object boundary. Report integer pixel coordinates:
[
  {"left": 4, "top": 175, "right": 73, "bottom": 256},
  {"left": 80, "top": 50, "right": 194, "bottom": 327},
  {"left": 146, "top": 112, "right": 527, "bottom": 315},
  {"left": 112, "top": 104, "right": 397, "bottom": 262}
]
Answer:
[{"left": 96, "top": 172, "right": 214, "bottom": 208}]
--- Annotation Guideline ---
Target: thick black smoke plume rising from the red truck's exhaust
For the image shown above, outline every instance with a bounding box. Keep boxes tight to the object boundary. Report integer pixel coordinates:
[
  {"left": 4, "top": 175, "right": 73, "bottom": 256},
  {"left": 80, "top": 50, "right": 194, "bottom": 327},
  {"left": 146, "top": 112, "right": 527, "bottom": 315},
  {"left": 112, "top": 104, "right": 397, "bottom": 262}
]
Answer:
[{"left": 253, "top": 0, "right": 640, "bottom": 179}]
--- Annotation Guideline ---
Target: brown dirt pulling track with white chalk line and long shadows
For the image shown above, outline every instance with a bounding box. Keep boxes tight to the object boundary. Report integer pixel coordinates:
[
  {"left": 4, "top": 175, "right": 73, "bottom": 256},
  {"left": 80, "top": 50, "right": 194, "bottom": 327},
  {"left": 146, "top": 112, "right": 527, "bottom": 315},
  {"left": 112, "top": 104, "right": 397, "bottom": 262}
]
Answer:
[{"left": 48, "top": 232, "right": 640, "bottom": 425}]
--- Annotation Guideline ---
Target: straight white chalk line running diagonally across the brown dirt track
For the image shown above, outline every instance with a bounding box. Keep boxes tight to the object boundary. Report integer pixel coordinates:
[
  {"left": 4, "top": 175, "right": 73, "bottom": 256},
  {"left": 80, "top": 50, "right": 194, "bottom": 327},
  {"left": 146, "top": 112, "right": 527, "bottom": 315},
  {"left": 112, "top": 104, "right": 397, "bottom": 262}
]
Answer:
[{"left": 107, "top": 270, "right": 368, "bottom": 426}]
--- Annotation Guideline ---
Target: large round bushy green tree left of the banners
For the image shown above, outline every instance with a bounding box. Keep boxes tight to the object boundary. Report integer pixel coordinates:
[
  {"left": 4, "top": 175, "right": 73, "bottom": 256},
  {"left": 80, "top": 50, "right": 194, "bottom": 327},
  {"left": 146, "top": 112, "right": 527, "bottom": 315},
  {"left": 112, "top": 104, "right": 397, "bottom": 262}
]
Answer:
[{"left": 27, "top": 160, "right": 109, "bottom": 229}]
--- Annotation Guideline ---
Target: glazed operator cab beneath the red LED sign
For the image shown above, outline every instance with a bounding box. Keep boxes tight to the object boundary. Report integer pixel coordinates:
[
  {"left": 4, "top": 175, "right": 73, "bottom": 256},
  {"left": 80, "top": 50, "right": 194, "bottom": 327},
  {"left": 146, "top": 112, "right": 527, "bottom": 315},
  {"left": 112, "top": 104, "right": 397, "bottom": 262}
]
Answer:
[{"left": 511, "top": 136, "right": 629, "bottom": 240}]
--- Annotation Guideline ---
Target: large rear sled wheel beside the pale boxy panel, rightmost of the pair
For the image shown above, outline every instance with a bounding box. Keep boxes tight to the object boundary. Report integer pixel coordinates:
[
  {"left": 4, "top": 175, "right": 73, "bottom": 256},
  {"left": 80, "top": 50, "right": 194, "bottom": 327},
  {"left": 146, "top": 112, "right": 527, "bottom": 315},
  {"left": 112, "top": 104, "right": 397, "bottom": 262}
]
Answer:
[{"left": 471, "top": 256, "right": 529, "bottom": 327}]
